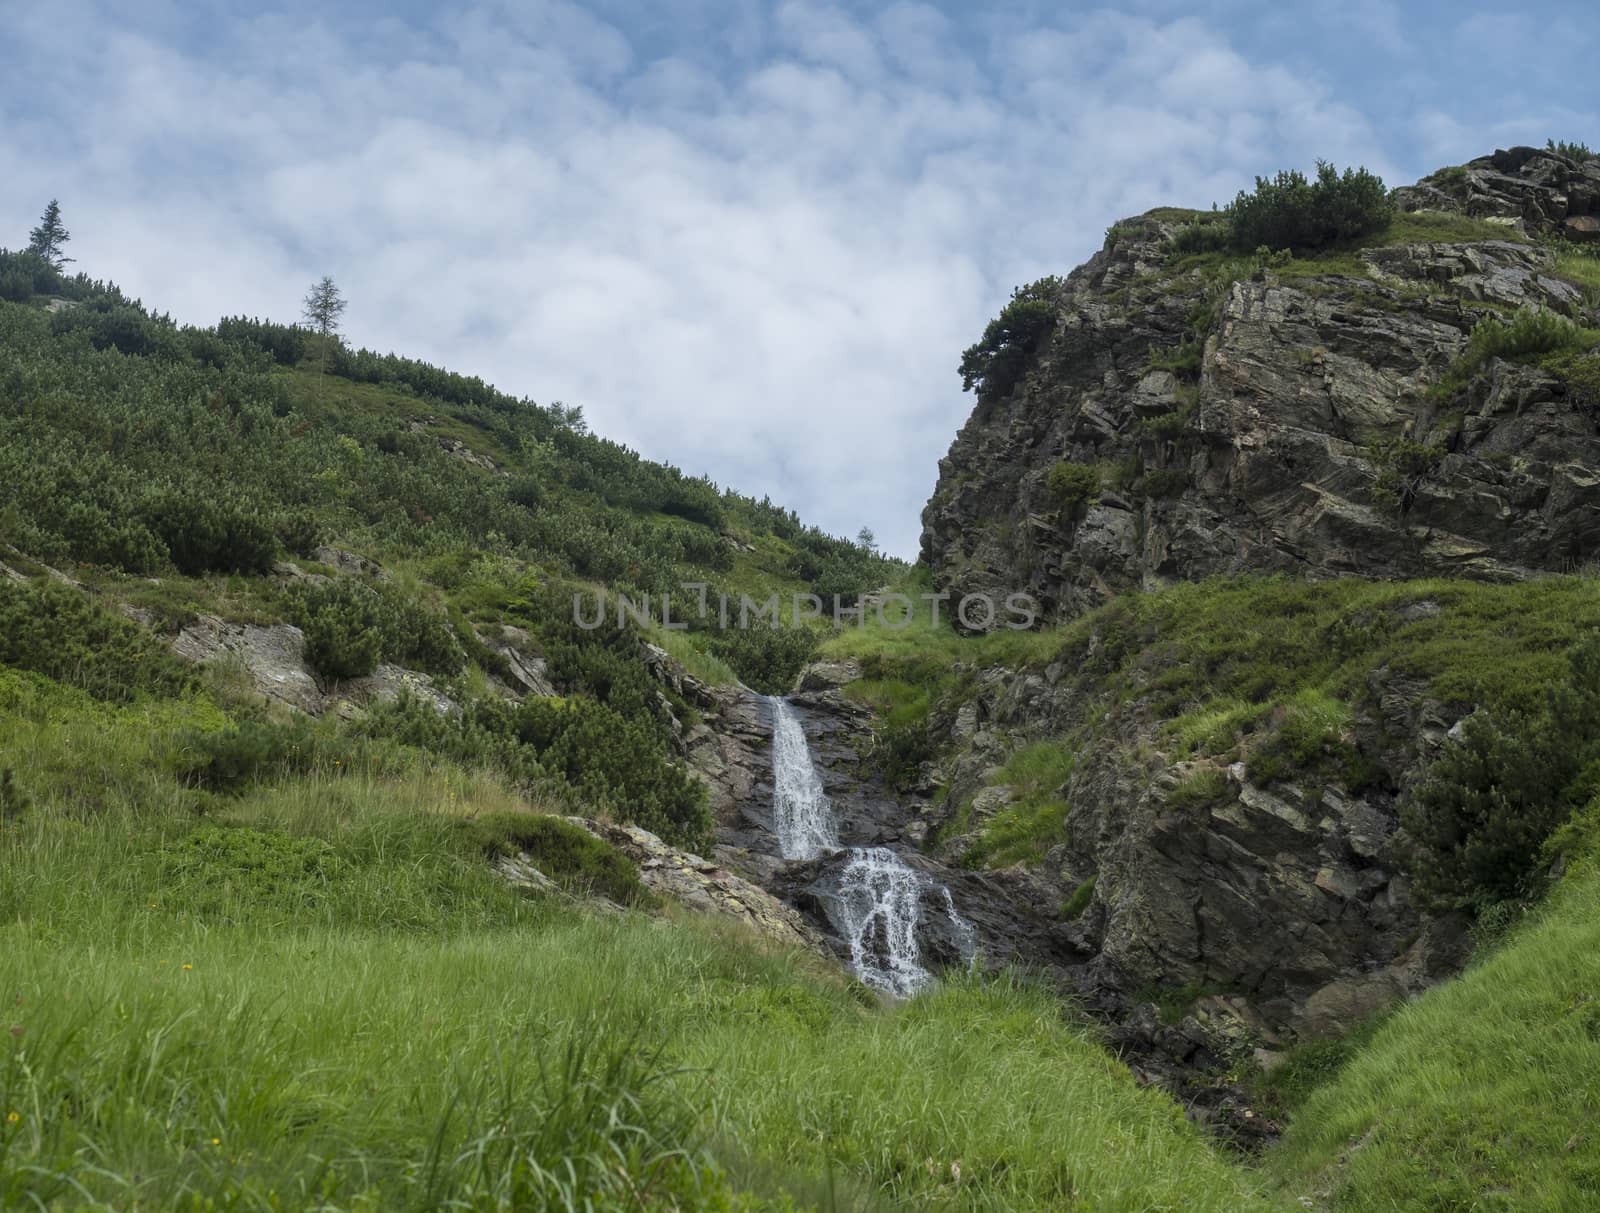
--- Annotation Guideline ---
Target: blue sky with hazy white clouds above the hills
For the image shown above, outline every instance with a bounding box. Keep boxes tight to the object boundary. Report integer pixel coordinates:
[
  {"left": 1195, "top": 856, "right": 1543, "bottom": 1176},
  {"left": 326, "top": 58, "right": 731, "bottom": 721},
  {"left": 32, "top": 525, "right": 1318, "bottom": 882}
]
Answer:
[{"left": 0, "top": 0, "right": 1600, "bottom": 557}]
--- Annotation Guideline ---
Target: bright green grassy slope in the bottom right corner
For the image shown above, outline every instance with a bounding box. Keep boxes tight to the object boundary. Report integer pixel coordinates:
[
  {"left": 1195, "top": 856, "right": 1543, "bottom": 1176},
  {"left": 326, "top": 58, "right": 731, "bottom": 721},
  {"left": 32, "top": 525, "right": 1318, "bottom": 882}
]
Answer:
[{"left": 1269, "top": 838, "right": 1600, "bottom": 1213}]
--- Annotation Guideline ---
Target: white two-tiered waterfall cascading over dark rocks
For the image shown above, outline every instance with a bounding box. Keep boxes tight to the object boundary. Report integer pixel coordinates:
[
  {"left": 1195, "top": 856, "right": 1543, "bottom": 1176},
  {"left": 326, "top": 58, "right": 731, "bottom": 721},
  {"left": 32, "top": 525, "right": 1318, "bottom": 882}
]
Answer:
[{"left": 771, "top": 698, "right": 973, "bottom": 999}]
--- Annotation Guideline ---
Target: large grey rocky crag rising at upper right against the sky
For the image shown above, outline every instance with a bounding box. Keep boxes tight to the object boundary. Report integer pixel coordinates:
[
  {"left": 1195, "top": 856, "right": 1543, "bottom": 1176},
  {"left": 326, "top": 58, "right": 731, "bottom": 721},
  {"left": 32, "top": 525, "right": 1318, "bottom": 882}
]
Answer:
[{"left": 922, "top": 149, "right": 1600, "bottom": 619}]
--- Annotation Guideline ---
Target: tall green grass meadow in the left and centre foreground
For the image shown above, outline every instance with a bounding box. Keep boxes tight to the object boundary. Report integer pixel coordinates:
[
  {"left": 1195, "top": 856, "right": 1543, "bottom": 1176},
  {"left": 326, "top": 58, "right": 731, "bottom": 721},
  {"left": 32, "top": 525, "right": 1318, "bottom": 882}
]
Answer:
[{"left": 0, "top": 672, "right": 1274, "bottom": 1213}]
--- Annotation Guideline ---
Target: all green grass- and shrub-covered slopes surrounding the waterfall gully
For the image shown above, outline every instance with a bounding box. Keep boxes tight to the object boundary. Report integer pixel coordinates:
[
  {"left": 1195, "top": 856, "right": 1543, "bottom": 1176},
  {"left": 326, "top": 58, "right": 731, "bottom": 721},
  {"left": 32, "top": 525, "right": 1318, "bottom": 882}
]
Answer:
[{"left": 0, "top": 211, "right": 1600, "bottom": 1213}]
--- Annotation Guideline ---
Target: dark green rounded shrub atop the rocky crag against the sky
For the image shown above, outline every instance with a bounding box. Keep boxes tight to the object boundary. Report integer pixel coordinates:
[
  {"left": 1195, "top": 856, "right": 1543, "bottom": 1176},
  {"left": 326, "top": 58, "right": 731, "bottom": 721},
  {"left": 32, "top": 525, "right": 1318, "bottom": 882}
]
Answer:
[{"left": 1227, "top": 160, "right": 1394, "bottom": 251}]
